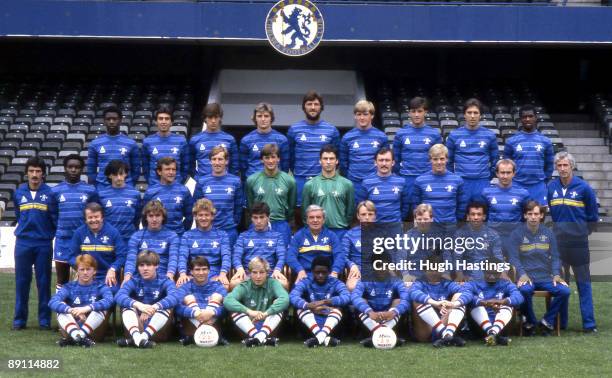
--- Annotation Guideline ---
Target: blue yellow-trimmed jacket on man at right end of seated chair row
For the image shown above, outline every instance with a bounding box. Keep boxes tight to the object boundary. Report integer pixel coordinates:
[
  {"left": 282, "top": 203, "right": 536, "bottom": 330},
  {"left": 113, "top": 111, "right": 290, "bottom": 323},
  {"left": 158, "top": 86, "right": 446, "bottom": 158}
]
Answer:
[{"left": 506, "top": 223, "right": 561, "bottom": 282}]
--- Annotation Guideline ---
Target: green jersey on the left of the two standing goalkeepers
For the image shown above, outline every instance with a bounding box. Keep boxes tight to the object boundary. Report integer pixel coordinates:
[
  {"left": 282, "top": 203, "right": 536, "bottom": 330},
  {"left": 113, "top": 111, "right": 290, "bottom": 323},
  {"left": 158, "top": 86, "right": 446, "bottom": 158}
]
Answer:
[{"left": 246, "top": 171, "right": 297, "bottom": 221}]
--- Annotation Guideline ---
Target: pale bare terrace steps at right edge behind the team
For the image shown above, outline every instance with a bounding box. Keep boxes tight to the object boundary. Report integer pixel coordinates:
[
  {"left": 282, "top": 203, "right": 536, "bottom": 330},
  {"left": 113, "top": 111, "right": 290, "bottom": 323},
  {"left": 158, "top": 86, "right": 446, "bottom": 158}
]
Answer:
[{"left": 552, "top": 114, "right": 612, "bottom": 214}]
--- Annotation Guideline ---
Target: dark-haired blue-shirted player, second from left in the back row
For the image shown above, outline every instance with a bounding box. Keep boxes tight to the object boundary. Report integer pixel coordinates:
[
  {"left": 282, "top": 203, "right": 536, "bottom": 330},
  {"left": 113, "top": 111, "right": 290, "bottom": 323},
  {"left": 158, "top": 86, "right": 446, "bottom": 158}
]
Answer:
[{"left": 142, "top": 107, "right": 190, "bottom": 186}]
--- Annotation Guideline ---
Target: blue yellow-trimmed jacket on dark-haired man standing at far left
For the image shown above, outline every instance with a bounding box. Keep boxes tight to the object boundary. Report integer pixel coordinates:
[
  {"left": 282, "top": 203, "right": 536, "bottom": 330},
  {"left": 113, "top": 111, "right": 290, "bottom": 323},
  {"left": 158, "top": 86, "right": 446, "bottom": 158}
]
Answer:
[{"left": 13, "top": 183, "right": 57, "bottom": 243}]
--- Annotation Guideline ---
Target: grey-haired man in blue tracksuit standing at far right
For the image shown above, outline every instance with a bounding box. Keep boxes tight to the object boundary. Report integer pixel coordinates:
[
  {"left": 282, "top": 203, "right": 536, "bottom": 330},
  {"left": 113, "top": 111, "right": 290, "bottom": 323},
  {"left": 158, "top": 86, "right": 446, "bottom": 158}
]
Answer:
[{"left": 548, "top": 151, "right": 598, "bottom": 333}]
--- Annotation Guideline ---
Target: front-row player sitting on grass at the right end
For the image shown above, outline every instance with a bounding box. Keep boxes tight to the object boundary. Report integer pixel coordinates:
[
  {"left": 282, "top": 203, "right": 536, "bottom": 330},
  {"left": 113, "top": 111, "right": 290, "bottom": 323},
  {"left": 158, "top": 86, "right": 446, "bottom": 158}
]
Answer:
[{"left": 466, "top": 258, "right": 523, "bottom": 345}]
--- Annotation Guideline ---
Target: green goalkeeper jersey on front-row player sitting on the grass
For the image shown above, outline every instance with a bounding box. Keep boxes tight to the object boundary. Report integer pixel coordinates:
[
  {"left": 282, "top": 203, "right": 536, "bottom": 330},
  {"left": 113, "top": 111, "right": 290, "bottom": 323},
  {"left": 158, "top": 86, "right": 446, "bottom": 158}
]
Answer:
[{"left": 223, "top": 278, "right": 289, "bottom": 315}]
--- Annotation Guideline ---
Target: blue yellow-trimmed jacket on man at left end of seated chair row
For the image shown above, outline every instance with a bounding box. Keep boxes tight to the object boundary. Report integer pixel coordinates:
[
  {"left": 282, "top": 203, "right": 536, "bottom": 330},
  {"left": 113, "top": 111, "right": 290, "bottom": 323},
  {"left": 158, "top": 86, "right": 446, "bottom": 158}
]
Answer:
[{"left": 68, "top": 223, "right": 127, "bottom": 281}]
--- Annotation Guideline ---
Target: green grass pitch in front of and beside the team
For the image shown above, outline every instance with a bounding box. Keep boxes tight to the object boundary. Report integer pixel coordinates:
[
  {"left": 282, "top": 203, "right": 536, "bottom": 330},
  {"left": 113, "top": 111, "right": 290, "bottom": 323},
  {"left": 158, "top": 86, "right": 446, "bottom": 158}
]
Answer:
[{"left": 0, "top": 273, "right": 612, "bottom": 377}]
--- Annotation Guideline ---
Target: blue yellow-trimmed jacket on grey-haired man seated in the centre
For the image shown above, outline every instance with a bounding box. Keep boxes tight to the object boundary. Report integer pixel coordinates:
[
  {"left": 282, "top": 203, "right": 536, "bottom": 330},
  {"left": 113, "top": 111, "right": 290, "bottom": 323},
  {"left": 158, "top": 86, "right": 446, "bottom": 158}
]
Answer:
[{"left": 287, "top": 226, "right": 345, "bottom": 273}]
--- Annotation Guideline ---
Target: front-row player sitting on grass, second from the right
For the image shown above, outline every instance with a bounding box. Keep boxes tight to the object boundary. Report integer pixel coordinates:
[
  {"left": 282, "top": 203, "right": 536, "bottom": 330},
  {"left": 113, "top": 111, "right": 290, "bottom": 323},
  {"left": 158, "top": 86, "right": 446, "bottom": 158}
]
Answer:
[{"left": 410, "top": 254, "right": 472, "bottom": 348}]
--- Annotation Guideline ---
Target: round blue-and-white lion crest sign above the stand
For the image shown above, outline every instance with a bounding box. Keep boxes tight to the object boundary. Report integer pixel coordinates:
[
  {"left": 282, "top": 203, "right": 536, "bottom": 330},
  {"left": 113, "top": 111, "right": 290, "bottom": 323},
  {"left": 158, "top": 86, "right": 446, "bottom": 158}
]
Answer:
[{"left": 266, "top": 0, "right": 324, "bottom": 56}]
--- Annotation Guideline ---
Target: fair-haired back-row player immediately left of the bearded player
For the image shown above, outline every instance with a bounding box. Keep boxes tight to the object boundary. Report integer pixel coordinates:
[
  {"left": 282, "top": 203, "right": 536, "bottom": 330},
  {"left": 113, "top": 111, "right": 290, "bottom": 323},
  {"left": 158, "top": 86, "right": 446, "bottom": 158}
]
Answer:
[{"left": 240, "top": 102, "right": 289, "bottom": 180}]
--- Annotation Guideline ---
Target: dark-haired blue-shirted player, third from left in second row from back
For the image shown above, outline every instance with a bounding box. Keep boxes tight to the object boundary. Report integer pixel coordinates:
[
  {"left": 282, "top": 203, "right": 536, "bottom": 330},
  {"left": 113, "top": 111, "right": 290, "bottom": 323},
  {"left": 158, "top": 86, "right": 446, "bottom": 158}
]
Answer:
[{"left": 98, "top": 160, "right": 142, "bottom": 244}]
